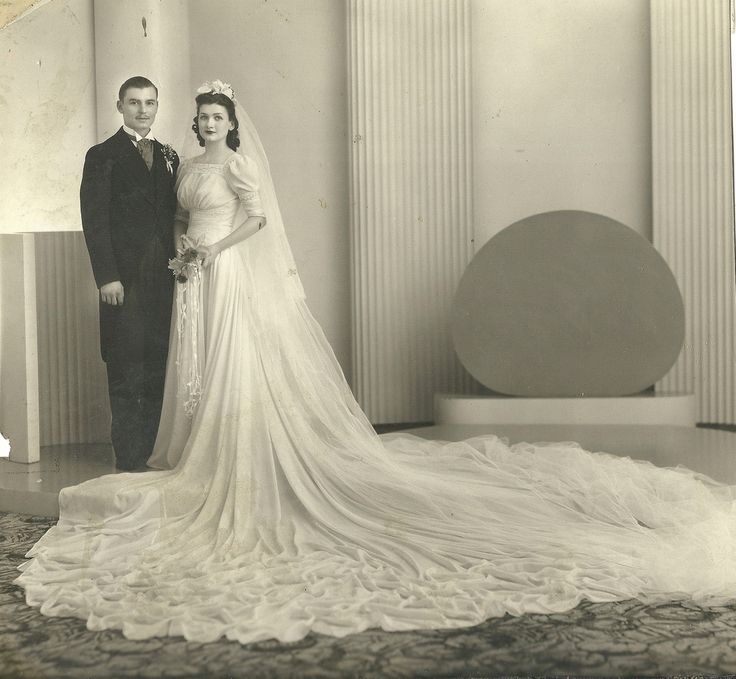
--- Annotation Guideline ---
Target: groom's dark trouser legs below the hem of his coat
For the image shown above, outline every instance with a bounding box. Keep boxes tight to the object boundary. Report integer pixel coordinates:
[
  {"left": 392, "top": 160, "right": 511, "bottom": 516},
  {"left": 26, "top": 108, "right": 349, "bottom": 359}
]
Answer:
[{"left": 107, "top": 357, "right": 166, "bottom": 470}]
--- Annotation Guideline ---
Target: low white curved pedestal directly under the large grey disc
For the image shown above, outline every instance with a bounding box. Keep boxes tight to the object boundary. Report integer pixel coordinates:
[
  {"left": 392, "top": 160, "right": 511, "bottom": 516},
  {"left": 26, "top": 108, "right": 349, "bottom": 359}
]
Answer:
[{"left": 434, "top": 393, "right": 696, "bottom": 427}]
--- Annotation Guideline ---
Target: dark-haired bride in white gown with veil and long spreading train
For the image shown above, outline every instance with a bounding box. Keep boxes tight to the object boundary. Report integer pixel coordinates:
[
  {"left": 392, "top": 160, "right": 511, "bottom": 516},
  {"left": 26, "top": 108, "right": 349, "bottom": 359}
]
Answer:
[{"left": 11, "top": 81, "right": 736, "bottom": 643}]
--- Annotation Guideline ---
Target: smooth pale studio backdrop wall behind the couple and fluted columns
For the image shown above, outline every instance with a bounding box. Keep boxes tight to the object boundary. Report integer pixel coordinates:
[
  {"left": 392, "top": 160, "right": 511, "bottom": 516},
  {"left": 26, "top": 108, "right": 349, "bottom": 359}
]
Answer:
[{"left": 0, "top": 0, "right": 728, "bottom": 444}]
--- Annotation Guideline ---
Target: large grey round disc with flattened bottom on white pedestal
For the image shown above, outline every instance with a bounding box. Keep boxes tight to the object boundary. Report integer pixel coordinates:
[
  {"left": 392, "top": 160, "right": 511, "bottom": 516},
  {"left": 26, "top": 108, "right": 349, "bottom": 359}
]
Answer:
[{"left": 451, "top": 210, "right": 685, "bottom": 397}]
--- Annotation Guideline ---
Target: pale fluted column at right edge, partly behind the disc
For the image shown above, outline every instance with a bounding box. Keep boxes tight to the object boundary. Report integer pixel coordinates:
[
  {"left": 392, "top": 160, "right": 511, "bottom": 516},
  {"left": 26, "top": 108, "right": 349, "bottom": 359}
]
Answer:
[{"left": 651, "top": 0, "right": 736, "bottom": 423}]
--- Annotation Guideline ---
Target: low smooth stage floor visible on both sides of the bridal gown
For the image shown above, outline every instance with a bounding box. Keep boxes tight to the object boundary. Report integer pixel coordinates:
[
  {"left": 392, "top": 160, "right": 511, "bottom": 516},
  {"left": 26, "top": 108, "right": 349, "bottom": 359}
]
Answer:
[{"left": 0, "top": 424, "right": 736, "bottom": 516}]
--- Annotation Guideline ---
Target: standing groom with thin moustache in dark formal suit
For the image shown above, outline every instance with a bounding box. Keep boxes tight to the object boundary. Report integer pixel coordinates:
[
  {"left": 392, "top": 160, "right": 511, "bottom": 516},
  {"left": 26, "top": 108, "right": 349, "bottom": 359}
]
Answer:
[{"left": 80, "top": 76, "right": 179, "bottom": 471}]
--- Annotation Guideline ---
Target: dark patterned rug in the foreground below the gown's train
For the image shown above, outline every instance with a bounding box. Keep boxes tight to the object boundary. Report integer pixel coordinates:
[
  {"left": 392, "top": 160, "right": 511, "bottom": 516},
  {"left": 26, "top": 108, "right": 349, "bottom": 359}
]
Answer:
[{"left": 0, "top": 513, "right": 736, "bottom": 679}]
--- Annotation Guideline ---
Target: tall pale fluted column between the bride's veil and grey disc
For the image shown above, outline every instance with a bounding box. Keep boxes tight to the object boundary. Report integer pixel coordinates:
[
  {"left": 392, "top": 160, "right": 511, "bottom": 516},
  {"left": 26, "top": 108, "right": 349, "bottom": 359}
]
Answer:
[{"left": 349, "top": 0, "right": 472, "bottom": 423}]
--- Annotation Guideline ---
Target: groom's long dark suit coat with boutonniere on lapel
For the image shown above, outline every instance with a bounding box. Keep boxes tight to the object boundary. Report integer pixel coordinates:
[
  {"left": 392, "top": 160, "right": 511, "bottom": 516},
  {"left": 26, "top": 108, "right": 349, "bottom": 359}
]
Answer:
[{"left": 80, "top": 127, "right": 179, "bottom": 362}]
